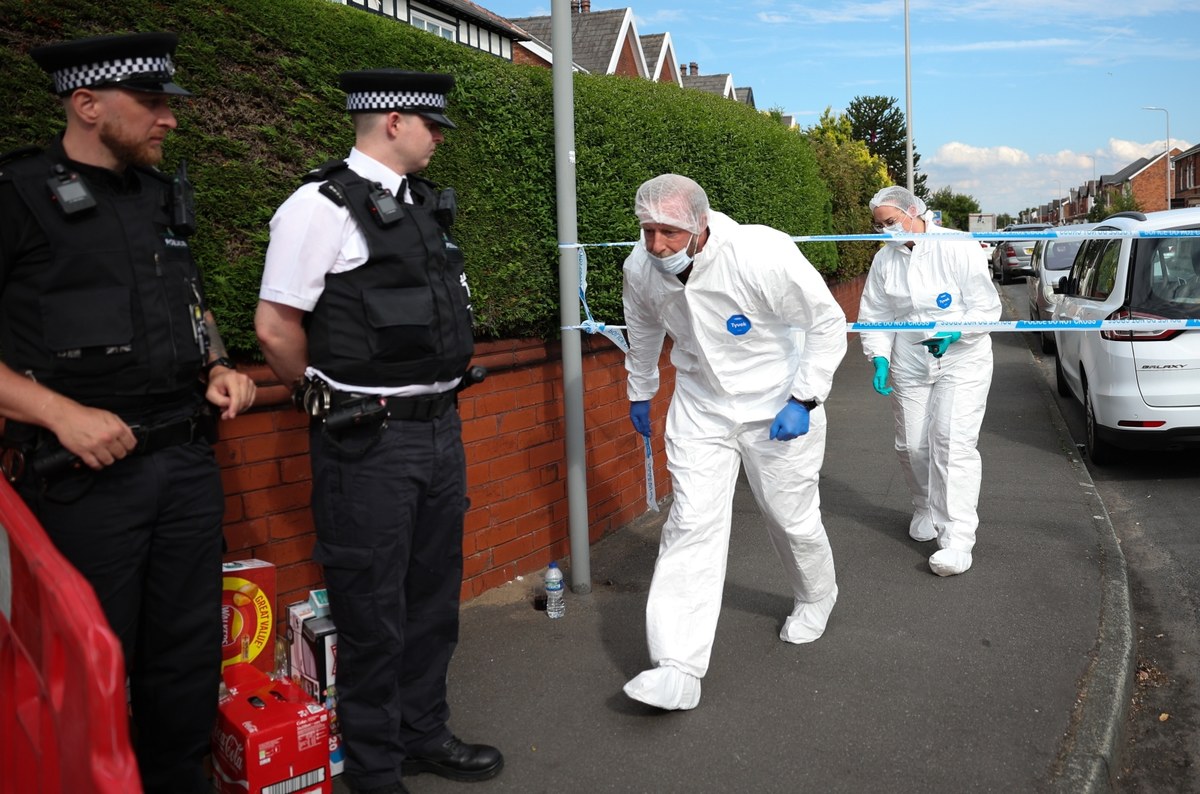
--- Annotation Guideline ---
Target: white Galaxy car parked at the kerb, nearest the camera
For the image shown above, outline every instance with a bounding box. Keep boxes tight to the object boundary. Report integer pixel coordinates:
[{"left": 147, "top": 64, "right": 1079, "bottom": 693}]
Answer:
[{"left": 1054, "top": 207, "right": 1200, "bottom": 465}]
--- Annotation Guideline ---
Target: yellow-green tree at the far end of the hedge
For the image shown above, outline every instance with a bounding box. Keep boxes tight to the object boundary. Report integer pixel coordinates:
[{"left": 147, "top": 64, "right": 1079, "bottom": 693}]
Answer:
[{"left": 800, "top": 108, "right": 888, "bottom": 281}]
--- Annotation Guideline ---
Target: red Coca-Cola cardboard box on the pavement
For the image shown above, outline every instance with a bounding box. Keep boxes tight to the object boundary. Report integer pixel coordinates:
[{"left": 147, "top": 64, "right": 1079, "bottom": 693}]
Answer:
[{"left": 212, "top": 663, "right": 332, "bottom": 794}]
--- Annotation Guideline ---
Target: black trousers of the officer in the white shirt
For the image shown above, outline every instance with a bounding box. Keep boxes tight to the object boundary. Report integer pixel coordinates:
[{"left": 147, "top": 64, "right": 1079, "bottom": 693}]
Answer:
[{"left": 311, "top": 409, "right": 467, "bottom": 788}]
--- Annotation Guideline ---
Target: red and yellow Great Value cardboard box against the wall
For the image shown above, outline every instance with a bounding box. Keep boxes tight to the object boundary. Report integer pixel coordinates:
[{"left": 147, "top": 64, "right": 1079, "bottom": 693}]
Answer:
[{"left": 221, "top": 560, "right": 275, "bottom": 673}]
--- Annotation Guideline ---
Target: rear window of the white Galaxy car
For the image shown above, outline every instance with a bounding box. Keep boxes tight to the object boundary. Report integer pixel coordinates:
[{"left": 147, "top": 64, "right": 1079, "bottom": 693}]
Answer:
[{"left": 1130, "top": 231, "right": 1200, "bottom": 318}]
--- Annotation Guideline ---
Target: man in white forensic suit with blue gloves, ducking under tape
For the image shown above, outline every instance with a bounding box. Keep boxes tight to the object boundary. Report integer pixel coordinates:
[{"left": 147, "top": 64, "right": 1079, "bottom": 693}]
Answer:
[{"left": 624, "top": 174, "right": 846, "bottom": 709}]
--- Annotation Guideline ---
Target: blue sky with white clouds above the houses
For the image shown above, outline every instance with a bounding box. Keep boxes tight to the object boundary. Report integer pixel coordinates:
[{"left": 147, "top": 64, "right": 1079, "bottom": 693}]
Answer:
[{"left": 480, "top": 0, "right": 1200, "bottom": 215}]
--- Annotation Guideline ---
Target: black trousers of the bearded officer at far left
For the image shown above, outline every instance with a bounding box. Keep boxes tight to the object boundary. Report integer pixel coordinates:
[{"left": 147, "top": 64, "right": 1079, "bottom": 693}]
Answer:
[{"left": 20, "top": 439, "right": 224, "bottom": 794}]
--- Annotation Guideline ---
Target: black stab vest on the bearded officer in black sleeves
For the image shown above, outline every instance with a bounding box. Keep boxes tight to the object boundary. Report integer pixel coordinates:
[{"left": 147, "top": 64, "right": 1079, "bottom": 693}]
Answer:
[{"left": 0, "top": 151, "right": 208, "bottom": 413}]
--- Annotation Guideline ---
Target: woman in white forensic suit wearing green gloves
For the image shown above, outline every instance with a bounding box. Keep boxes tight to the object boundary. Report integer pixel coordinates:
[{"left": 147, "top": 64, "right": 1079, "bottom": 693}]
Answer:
[{"left": 858, "top": 187, "right": 1000, "bottom": 576}]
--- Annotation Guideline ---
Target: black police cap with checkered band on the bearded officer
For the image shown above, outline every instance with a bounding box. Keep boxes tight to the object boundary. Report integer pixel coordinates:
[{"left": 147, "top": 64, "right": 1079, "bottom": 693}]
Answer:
[{"left": 29, "top": 34, "right": 192, "bottom": 96}]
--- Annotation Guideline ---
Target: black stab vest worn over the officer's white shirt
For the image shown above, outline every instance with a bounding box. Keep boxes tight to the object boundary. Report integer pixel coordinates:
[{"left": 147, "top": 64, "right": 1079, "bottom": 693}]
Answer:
[{"left": 305, "top": 161, "right": 475, "bottom": 386}]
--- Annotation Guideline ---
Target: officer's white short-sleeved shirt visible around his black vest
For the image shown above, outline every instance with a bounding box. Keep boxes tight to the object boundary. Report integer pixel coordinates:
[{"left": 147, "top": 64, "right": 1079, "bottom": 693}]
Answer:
[{"left": 258, "top": 149, "right": 460, "bottom": 396}]
